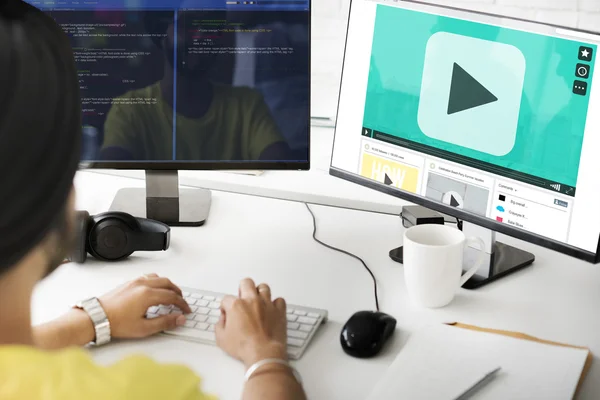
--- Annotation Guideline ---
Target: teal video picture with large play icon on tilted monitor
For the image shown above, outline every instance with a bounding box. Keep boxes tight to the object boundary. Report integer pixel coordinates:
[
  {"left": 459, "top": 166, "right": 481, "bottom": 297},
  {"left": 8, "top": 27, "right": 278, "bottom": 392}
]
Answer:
[{"left": 363, "top": 6, "right": 595, "bottom": 191}]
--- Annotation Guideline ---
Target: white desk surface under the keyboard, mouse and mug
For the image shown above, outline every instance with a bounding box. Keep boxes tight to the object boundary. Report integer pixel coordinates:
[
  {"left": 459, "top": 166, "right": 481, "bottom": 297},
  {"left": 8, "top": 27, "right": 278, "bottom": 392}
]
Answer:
[{"left": 32, "top": 173, "right": 600, "bottom": 400}]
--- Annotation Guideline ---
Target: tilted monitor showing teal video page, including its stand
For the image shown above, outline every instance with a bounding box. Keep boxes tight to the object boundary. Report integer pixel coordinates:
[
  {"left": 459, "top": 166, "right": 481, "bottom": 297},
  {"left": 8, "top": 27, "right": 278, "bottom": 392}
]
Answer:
[{"left": 330, "top": 0, "right": 600, "bottom": 287}]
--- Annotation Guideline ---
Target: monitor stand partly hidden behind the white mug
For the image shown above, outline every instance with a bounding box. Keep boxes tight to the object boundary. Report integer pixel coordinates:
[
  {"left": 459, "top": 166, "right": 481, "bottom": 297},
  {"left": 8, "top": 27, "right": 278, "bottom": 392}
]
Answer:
[{"left": 390, "top": 216, "right": 535, "bottom": 289}]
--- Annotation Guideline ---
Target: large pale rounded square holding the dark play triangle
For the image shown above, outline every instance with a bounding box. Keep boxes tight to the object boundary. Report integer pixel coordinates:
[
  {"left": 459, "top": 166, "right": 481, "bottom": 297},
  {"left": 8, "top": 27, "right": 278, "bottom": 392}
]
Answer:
[{"left": 418, "top": 32, "right": 526, "bottom": 156}]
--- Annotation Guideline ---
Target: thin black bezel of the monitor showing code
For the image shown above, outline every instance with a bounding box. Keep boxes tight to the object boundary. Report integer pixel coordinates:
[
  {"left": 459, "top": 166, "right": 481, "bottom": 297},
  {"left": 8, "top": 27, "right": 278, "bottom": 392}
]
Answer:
[{"left": 81, "top": 0, "right": 313, "bottom": 171}]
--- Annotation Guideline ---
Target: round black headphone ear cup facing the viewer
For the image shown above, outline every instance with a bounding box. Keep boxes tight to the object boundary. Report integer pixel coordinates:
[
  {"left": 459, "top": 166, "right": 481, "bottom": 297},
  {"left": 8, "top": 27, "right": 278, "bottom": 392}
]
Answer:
[{"left": 88, "top": 213, "right": 133, "bottom": 261}]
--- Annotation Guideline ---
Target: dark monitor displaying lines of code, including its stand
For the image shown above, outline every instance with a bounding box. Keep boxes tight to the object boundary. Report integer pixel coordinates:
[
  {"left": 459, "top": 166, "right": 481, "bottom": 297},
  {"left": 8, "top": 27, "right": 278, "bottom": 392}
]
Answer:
[{"left": 29, "top": 0, "right": 310, "bottom": 225}]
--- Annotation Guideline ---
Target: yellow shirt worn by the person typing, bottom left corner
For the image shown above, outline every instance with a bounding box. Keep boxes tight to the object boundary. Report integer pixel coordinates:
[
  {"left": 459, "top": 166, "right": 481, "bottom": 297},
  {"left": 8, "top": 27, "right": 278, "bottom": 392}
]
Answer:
[{"left": 0, "top": 346, "right": 215, "bottom": 400}]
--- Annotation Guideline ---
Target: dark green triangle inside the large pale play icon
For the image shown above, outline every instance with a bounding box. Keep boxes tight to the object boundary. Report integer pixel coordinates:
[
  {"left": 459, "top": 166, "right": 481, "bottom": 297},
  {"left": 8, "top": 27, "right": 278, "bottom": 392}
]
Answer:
[{"left": 448, "top": 63, "right": 498, "bottom": 115}]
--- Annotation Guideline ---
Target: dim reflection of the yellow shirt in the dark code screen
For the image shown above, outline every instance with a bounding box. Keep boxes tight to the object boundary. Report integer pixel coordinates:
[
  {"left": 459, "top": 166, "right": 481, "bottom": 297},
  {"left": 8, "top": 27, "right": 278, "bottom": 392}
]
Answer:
[{"left": 102, "top": 83, "right": 283, "bottom": 161}]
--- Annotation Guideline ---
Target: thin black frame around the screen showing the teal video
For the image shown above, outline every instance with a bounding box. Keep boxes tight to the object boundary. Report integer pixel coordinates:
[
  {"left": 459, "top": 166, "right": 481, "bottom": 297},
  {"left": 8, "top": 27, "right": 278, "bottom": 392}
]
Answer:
[{"left": 329, "top": 0, "right": 600, "bottom": 264}]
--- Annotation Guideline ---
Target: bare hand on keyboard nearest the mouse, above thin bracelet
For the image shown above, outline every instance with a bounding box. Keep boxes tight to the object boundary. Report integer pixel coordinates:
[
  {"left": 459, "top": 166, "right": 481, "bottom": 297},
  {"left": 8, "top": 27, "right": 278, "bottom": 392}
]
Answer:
[{"left": 215, "top": 279, "right": 288, "bottom": 368}]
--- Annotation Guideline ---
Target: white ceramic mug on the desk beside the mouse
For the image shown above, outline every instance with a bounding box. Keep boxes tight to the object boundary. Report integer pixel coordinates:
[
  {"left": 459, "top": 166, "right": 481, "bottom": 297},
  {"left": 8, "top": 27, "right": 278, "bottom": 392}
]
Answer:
[{"left": 403, "top": 224, "right": 485, "bottom": 308}]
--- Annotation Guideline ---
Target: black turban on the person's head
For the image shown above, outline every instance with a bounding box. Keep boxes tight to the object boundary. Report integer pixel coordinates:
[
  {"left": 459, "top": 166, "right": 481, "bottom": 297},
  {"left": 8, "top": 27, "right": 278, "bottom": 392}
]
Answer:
[{"left": 0, "top": 0, "right": 81, "bottom": 273}]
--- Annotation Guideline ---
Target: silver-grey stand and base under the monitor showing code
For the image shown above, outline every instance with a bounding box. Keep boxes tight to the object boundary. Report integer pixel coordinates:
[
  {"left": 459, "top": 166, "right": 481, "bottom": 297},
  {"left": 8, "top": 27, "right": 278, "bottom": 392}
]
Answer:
[{"left": 110, "top": 170, "right": 211, "bottom": 226}]
